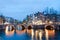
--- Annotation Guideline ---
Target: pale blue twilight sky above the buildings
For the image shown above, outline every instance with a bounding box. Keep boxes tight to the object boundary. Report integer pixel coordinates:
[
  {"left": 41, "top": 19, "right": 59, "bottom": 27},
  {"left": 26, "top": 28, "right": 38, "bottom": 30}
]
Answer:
[{"left": 0, "top": 0, "right": 60, "bottom": 20}]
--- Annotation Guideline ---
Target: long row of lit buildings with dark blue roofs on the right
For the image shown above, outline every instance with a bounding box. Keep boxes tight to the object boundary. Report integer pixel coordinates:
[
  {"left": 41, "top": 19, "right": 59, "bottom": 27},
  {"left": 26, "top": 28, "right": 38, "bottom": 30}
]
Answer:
[{"left": 28, "top": 12, "right": 60, "bottom": 23}]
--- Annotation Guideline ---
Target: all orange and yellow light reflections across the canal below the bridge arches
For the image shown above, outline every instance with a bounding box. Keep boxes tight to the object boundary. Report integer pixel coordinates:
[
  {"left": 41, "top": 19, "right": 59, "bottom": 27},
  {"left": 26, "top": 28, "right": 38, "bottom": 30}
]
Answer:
[{"left": 5, "top": 27, "right": 55, "bottom": 40}]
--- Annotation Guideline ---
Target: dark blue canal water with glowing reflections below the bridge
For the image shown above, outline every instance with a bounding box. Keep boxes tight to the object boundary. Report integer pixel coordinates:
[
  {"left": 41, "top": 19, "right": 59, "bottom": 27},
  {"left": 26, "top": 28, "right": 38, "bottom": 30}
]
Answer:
[{"left": 0, "top": 29, "right": 60, "bottom": 40}]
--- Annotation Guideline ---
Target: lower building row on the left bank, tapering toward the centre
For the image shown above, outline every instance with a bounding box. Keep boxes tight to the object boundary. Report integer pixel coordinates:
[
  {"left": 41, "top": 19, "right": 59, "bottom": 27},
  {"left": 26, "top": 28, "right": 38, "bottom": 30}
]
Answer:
[{"left": 0, "top": 15, "right": 20, "bottom": 25}]
